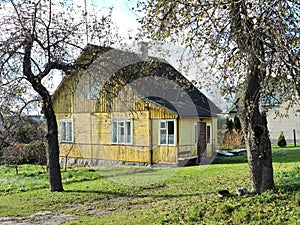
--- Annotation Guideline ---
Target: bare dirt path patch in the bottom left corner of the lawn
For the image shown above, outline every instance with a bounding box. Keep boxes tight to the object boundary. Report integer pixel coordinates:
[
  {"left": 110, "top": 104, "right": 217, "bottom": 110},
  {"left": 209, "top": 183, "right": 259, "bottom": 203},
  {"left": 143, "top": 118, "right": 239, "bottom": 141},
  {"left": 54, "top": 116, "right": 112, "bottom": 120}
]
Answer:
[{"left": 0, "top": 211, "right": 75, "bottom": 225}]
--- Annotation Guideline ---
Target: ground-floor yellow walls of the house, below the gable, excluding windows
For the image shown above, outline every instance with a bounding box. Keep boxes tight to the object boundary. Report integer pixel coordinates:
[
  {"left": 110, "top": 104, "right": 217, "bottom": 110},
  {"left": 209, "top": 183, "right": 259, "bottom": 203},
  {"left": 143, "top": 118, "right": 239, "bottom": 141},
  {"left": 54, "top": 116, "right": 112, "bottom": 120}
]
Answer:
[{"left": 57, "top": 107, "right": 216, "bottom": 163}]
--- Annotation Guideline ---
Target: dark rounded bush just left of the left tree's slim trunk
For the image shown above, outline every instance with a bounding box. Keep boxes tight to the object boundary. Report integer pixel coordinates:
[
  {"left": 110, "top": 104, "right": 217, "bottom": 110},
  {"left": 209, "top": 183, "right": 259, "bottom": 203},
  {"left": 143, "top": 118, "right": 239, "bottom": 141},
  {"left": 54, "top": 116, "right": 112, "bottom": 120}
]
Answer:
[{"left": 24, "top": 141, "right": 47, "bottom": 165}]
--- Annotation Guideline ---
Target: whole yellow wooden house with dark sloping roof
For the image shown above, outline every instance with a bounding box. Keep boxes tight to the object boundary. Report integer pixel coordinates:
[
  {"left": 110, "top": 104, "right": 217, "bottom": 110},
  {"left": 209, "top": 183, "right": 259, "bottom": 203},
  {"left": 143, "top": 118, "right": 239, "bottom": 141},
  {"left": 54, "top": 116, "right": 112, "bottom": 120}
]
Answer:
[{"left": 53, "top": 45, "right": 220, "bottom": 166}]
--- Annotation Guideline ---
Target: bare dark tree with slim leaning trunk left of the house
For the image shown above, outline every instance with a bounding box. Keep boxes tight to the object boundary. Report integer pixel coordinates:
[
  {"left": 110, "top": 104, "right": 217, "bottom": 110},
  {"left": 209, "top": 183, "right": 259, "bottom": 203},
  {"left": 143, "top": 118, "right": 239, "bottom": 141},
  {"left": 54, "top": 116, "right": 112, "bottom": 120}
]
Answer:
[{"left": 0, "top": 0, "right": 110, "bottom": 191}]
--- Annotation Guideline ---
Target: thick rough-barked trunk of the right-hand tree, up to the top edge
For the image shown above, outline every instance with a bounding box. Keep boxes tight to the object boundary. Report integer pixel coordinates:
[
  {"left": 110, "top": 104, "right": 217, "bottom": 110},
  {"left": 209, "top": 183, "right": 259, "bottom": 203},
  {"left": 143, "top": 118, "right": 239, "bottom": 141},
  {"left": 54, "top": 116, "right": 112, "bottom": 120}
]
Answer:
[{"left": 231, "top": 0, "right": 274, "bottom": 193}]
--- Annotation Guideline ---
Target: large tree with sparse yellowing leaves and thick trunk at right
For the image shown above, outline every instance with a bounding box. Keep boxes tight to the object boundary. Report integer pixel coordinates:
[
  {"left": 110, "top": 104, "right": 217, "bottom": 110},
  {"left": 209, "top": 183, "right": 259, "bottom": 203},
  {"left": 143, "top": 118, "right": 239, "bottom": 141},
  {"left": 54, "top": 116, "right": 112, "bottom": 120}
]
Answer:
[{"left": 139, "top": 0, "right": 300, "bottom": 193}]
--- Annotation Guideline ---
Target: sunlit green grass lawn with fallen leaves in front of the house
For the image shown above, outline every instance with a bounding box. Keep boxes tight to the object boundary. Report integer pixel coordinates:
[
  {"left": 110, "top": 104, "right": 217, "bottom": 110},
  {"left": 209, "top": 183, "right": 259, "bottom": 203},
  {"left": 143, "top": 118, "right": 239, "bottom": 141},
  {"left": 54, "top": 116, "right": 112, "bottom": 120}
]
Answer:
[{"left": 0, "top": 147, "right": 300, "bottom": 225}]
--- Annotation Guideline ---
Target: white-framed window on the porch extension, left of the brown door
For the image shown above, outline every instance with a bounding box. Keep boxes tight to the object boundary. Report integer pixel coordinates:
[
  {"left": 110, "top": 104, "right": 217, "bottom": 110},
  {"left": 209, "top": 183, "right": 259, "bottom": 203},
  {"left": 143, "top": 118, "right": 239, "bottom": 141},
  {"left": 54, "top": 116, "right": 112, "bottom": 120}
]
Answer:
[{"left": 159, "top": 120, "right": 176, "bottom": 145}]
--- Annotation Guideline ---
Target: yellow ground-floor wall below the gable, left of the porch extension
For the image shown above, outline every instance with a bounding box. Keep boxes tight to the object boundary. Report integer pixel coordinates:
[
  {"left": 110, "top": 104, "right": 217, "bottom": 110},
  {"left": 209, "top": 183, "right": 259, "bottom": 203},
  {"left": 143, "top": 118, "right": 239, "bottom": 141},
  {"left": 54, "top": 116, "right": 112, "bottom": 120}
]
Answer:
[{"left": 57, "top": 111, "right": 150, "bottom": 163}]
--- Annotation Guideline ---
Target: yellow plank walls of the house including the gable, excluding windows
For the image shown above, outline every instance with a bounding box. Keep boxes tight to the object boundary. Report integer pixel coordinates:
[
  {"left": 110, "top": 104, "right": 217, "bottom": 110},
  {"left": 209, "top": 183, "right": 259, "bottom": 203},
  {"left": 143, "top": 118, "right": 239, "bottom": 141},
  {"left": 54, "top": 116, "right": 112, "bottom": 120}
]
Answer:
[{"left": 54, "top": 68, "right": 217, "bottom": 163}]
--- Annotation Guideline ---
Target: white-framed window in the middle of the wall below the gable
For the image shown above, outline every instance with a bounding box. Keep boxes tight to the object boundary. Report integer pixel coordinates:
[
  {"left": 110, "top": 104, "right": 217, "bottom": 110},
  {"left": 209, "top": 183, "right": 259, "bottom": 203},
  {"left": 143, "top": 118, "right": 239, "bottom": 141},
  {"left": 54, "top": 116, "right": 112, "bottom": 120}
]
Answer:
[{"left": 111, "top": 119, "right": 132, "bottom": 144}]
